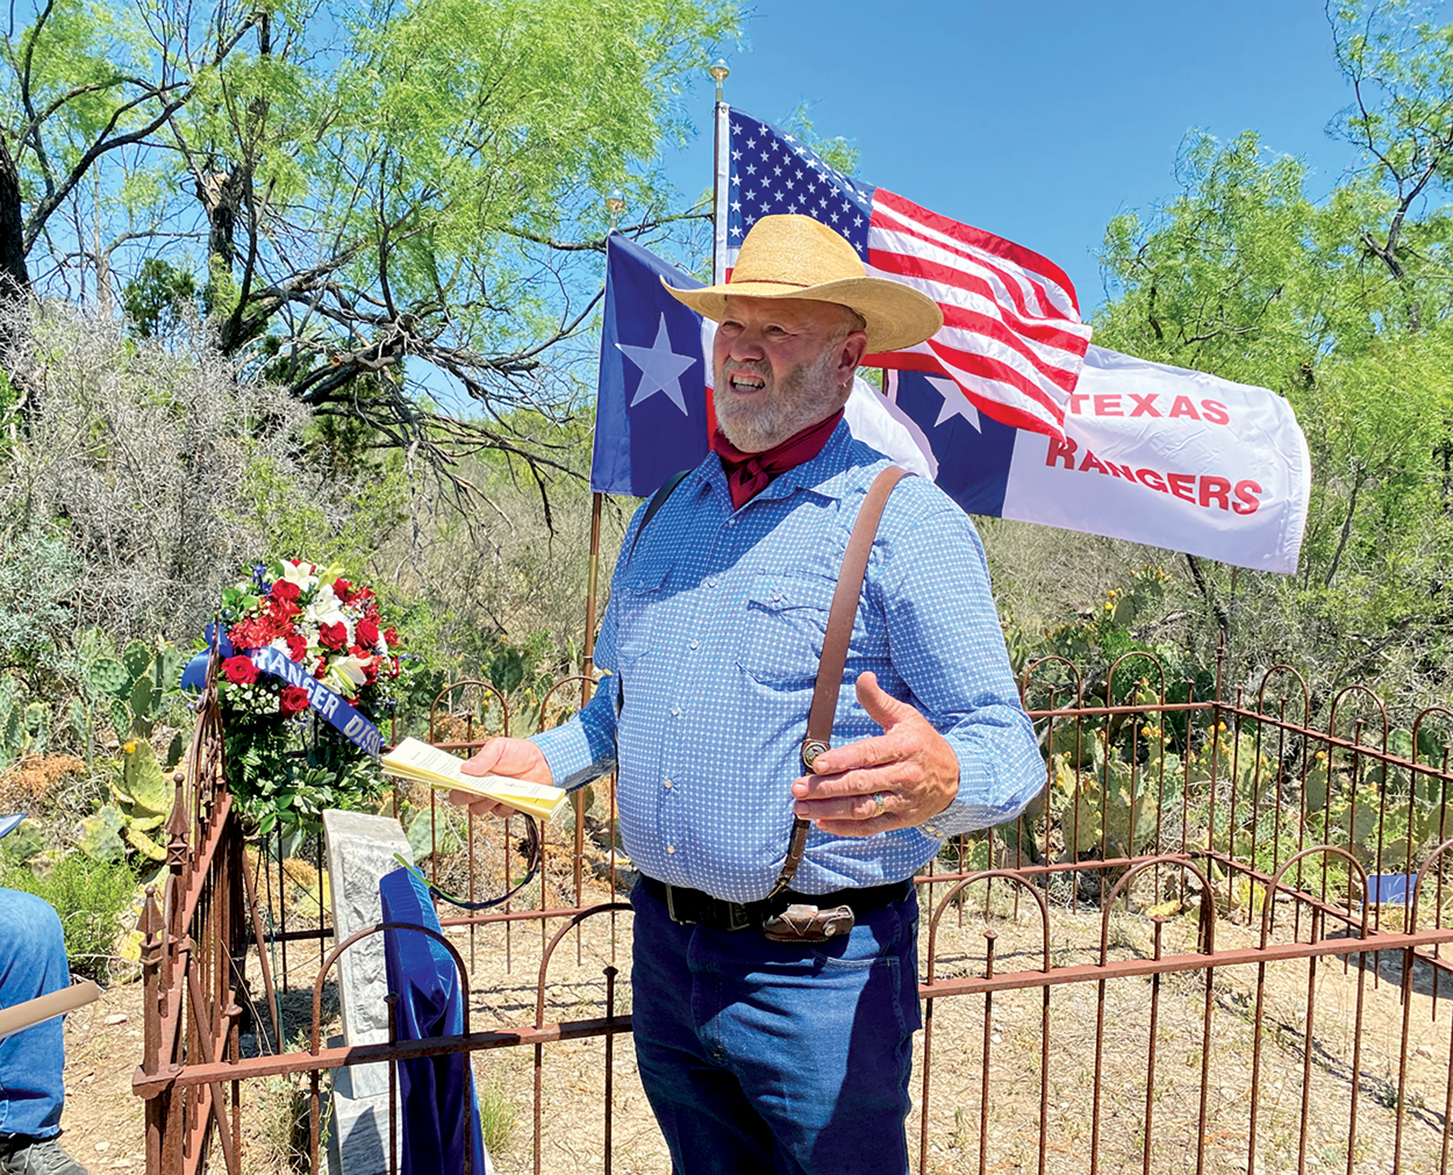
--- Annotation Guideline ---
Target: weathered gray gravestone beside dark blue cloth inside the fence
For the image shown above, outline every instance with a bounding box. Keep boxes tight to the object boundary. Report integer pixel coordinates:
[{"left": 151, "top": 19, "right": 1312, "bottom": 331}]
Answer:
[{"left": 323, "top": 810, "right": 414, "bottom": 1175}]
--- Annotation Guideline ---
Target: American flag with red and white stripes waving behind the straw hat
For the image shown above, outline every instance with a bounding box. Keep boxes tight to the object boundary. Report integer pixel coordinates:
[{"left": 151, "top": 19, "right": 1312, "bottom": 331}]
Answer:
[{"left": 727, "top": 110, "right": 1090, "bottom": 437}]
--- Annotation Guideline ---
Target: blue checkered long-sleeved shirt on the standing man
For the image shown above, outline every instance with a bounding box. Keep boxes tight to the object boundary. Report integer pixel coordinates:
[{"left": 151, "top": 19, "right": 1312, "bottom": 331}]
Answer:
[{"left": 535, "top": 423, "right": 1045, "bottom": 902}]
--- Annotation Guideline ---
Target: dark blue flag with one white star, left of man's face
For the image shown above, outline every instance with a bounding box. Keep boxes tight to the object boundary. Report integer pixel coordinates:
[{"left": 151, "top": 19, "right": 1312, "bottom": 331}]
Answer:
[{"left": 590, "top": 232, "right": 712, "bottom": 498}]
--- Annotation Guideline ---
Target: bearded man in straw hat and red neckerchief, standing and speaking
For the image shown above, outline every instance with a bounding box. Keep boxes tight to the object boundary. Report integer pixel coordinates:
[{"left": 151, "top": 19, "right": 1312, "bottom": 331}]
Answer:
[{"left": 459, "top": 216, "right": 1043, "bottom": 1175}]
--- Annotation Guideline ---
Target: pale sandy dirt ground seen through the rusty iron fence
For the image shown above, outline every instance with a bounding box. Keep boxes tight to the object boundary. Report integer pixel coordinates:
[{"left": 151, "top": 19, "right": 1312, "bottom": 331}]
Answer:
[{"left": 53, "top": 859, "right": 1453, "bottom": 1175}]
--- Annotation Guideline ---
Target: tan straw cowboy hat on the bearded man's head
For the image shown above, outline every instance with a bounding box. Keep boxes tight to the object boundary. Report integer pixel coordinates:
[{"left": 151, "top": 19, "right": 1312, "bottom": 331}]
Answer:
[{"left": 661, "top": 215, "right": 943, "bottom": 353}]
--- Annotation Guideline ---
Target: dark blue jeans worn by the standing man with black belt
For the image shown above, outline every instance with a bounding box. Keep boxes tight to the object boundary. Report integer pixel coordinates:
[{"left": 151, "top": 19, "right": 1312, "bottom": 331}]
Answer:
[{"left": 631, "top": 885, "right": 920, "bottom": 1175}]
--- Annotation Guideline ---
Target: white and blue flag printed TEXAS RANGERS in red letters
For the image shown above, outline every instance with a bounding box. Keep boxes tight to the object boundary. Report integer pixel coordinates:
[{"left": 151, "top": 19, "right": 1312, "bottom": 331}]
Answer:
[{"left": 886, "top": 347, "right": 1312, "bottom": 574}]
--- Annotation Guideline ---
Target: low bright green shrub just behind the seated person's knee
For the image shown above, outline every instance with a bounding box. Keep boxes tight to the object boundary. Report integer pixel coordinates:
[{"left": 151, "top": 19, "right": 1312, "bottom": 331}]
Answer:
[{"left": 0, "top": 853, "right": 137, "bottom": 979}]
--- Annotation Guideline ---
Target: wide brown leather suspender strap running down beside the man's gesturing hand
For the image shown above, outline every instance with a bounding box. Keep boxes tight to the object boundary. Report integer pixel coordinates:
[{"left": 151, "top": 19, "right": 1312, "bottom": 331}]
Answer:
[{"left": 767, "top": 465, "right": 907, "bottom": 899}]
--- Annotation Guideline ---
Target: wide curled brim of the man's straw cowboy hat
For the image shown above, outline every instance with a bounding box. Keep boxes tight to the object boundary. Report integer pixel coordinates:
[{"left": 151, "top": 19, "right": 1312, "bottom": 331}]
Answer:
[{"left": 661, "top": 277, "right": 943, "bottom": 354}]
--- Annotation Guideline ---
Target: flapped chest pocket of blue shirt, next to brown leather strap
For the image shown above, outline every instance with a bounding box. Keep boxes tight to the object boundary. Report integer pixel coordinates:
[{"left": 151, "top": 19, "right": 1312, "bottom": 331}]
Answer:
[{"left": 737, "top": 575, "right": 834, "bottom": 688}]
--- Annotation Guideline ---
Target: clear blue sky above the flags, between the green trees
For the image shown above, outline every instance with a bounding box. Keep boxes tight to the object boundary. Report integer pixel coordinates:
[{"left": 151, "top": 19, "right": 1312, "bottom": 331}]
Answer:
[{"left": 665, "top": 0, "right": 1351, "bottom": 312}]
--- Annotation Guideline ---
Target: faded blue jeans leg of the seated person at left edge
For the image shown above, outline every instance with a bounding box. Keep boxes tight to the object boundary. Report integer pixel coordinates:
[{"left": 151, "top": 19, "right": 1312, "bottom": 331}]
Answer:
[{"left": 0, "top": 889, "right": 71, "bottom": 1139}]
